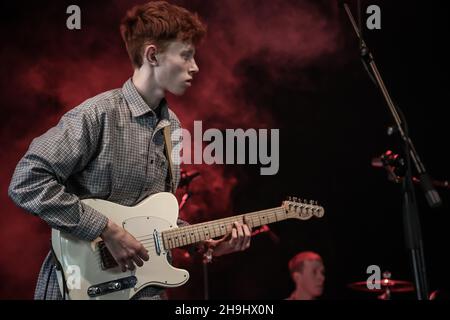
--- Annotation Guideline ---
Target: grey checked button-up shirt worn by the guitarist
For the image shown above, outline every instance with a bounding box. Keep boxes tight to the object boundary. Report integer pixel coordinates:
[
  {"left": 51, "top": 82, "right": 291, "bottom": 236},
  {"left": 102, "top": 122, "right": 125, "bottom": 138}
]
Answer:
[{"left": 8, "top": 79, "right": 183, "bottom": 299}]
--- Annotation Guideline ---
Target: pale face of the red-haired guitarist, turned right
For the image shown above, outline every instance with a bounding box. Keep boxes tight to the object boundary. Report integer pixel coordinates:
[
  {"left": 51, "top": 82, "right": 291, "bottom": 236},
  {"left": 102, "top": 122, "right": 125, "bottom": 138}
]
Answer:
[{"left": 155, "top": 41, "right": 199, "bottom": 95}]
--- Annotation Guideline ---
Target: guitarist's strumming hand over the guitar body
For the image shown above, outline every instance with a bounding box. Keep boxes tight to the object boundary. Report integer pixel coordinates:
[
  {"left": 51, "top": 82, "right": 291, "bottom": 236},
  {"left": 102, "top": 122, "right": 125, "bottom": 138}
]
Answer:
[{"left": 100, "top": 220, "right": 149, "bottom": 272}]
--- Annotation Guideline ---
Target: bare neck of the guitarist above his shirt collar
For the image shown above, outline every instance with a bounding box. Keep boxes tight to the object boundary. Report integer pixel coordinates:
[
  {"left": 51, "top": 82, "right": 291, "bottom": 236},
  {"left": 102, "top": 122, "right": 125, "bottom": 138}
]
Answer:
[{"left": 132, "top": 68, "right": 164, "bottom": 110}]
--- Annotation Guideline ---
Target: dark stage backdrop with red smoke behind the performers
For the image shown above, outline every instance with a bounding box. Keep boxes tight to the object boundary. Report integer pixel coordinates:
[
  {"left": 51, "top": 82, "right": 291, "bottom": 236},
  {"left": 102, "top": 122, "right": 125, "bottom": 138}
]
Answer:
[{"left": 0, "top": 0, "right": 449, "bottom": 299}]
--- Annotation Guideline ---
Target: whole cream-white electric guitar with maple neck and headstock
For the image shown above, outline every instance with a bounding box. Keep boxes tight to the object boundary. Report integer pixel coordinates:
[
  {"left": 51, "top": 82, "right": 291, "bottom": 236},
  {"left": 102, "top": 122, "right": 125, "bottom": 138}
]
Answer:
[{"left": 52, "top": 192, "right": 324, "bottom": 300}]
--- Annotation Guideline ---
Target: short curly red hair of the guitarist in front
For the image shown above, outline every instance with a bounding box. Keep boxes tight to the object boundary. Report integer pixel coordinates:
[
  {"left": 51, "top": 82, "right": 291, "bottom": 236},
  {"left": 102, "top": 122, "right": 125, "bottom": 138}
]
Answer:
[{"left": 120, "top": 1, "right": 206, "bottom": 68}]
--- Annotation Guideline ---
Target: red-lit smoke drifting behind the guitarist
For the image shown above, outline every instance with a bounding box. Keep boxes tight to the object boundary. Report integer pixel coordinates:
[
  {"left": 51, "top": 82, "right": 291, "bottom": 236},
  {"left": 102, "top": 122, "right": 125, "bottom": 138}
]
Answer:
[{"left": 0, "top": 0, "right": 340, "bottom": 298}]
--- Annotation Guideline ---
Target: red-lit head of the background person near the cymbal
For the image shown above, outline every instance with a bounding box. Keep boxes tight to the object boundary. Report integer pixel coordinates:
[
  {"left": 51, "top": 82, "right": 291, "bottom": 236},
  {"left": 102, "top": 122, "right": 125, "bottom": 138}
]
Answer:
[{"left": 287, "top": 251, "right": 325, "bottom": 300}]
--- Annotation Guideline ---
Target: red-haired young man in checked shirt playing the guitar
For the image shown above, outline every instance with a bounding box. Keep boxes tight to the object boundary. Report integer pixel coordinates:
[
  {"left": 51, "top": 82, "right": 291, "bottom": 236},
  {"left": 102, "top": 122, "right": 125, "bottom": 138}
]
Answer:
[{"left": 9, "top": 1, "right": 251, "bottom": 299}]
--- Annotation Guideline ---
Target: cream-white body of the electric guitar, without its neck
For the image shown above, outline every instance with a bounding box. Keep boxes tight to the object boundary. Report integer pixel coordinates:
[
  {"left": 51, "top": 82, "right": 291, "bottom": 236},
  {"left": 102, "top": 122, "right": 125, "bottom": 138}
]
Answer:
[{"left": 52, "top": 192, "right": 189, "bottom": 300}]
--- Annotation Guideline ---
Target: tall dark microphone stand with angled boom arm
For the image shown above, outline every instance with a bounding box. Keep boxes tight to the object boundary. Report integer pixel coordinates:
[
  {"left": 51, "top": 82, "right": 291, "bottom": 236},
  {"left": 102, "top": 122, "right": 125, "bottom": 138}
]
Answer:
[{"left": 340, "top": 1, "right": 442, "bottom": 300}]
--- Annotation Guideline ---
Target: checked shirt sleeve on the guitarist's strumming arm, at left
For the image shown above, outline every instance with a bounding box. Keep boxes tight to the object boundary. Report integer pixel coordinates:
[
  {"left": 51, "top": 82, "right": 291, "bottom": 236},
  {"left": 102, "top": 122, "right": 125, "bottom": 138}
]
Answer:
[{"left": 8, "top": 106, "right": 108, "bottom": 240}]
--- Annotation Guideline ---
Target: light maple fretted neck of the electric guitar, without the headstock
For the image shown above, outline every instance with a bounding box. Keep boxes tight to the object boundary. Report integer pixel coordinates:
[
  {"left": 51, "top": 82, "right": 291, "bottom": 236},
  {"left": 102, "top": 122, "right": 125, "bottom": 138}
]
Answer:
[{"left": 162, "top": 207, "right": 291, "bottom": 249}]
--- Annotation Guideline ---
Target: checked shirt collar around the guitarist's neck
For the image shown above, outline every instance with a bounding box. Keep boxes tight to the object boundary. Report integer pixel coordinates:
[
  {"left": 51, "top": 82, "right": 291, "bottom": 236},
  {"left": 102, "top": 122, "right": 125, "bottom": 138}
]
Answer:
[{"left": 122, "top": 78, "right": 169, "bottom": 120}]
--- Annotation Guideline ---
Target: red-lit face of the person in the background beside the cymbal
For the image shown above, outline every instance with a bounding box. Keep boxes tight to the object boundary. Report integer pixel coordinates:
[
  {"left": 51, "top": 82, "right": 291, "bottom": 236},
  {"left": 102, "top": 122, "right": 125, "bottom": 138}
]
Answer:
[{"left": 297, "top": 260, "right": 325, "bottom": 297}]
